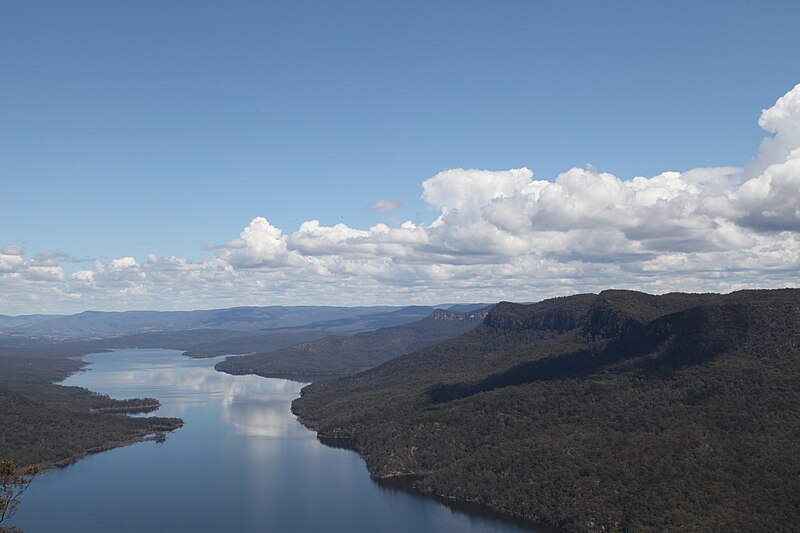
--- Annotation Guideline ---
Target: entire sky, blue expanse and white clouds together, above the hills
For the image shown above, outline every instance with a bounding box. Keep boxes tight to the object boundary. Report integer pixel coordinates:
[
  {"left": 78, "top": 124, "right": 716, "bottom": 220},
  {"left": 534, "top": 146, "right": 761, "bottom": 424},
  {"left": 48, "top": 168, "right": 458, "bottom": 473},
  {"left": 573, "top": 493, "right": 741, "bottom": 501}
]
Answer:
[{"left": 0, "top": 0, "right": 800, "bottom": 315}]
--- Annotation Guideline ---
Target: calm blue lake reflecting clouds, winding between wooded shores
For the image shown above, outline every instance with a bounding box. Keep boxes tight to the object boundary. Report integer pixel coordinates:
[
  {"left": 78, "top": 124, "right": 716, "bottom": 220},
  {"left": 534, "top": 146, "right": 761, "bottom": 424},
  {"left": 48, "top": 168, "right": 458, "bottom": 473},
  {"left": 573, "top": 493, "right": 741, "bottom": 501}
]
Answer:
[{"left": 12, "top": 350, "right": 552, "bottom": 533}]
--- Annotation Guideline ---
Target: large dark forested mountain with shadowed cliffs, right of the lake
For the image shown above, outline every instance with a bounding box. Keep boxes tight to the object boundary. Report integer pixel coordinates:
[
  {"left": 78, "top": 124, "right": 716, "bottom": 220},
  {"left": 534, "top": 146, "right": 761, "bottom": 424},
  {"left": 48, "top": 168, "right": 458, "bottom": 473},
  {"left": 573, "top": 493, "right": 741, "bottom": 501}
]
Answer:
[{"left": 293, "top": 289, "right": 800, "bottom": 532}]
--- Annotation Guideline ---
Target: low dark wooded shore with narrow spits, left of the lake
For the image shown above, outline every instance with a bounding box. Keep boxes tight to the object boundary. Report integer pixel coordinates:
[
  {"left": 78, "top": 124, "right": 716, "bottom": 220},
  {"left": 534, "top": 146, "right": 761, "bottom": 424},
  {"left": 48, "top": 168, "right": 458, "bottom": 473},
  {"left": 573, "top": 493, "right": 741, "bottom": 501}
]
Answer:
[{"left": 0, "top": 347, "right": 183, "bottom": 466}]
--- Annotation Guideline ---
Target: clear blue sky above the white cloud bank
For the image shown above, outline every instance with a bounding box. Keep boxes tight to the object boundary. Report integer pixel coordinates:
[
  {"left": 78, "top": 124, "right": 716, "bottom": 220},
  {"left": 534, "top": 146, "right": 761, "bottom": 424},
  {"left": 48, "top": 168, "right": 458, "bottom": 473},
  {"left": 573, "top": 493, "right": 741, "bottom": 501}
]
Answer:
[{"left": 0, "top": 1, "right": 800, "bottom": 313}]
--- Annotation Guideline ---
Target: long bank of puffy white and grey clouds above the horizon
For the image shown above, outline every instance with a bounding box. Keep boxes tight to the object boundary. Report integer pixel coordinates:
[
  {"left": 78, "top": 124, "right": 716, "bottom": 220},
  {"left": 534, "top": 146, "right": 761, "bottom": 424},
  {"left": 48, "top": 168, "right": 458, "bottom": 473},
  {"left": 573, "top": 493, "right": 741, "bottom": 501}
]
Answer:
[{"left": 0, "top": 84, "right": 800, "bottom": 313}]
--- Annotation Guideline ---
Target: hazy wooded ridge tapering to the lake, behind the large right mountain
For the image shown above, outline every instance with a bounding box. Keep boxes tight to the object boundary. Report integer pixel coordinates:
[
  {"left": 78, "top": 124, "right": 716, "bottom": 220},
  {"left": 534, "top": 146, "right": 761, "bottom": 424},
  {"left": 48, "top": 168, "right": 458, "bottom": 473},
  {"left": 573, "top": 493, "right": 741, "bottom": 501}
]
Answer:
[{"left": 214, "top": 309, "right": 486, "bottom": 380}]
